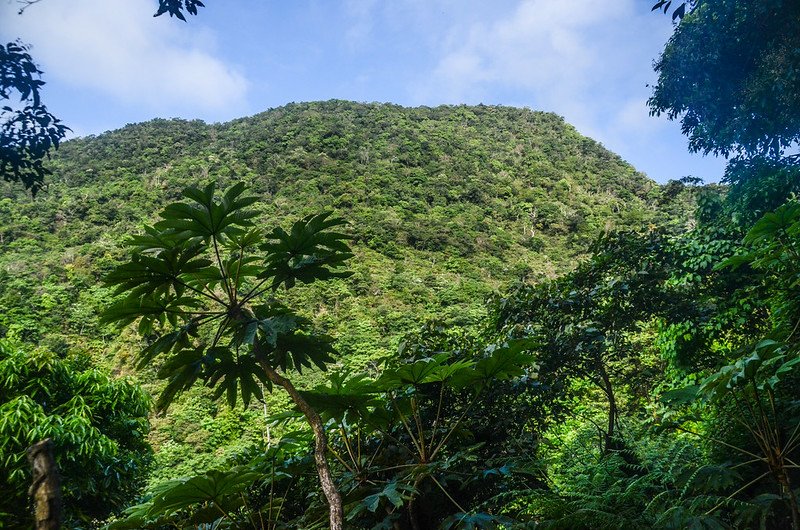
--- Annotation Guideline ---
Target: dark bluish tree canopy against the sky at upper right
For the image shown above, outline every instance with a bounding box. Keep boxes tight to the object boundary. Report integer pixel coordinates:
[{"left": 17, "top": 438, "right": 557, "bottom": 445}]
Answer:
[{"left": 649, "top": 0, "right": 800, "bottom": 157}]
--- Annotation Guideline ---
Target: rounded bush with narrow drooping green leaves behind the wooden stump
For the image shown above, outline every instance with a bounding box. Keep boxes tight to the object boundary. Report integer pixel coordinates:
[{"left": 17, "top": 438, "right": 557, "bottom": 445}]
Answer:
[{"left": 0, "top": 341, "right": 151, "bottom": 528}]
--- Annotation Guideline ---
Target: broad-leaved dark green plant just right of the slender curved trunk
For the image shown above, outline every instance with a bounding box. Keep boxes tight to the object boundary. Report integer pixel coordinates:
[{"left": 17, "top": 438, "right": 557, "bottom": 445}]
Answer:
[{"left": 294, "top": 340, "right": 538, "bottom": 528}]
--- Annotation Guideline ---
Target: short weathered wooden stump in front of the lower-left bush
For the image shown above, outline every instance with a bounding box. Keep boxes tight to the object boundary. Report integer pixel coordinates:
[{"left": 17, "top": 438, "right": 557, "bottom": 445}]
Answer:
[{"left": 27, "top": 438, "right": 61, "bottom": 530}]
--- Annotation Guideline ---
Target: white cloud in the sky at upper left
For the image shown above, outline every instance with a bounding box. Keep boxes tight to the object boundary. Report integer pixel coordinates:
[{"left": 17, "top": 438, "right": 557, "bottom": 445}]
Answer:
[{"left": 0, "top": 0, "right": 247, "bottom": 118}]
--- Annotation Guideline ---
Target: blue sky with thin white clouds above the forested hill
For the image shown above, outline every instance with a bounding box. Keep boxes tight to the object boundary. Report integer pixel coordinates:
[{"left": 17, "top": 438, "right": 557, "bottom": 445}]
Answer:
[{"left": 0, "top": 0, "right": 724, "bottom": 182}]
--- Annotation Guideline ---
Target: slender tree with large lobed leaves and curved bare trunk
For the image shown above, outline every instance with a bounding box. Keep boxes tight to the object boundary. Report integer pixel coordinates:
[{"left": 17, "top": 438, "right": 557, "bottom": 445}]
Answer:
[{"left": 103, "top": 183, "right": 352, "bottom": 526}]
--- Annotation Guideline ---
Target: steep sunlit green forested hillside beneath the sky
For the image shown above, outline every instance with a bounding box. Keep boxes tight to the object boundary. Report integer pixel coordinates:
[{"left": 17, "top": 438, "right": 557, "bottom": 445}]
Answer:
[{"left": 0, "top": 101, "right": 684, "bottom": 475}]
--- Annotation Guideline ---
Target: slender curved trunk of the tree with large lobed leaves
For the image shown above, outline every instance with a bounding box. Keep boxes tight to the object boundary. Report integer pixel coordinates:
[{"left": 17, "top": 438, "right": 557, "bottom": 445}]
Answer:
[{"left": 260, "top": 361, "right": 344, "bottom": 530}]
